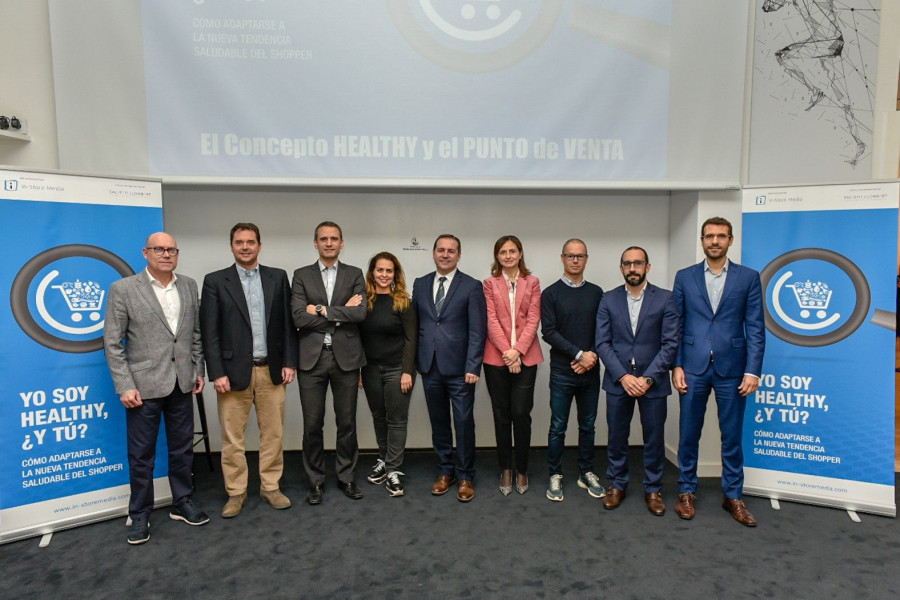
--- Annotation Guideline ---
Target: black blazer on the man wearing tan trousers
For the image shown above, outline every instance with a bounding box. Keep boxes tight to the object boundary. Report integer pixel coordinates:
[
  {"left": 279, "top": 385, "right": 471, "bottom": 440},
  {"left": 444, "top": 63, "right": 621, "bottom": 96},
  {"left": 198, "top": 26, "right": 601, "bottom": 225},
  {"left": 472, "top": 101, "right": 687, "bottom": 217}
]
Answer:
[{"left": 200, "top": 265, "right": 297, "bottom": 390}]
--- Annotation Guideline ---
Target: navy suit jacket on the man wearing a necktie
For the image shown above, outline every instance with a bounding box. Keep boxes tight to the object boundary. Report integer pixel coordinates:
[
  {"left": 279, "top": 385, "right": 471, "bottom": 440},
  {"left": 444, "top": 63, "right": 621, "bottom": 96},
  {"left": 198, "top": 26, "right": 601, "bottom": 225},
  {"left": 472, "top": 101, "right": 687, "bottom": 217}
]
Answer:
[{"left": 413, "top": 271, "right": 487, "bottom": 375}]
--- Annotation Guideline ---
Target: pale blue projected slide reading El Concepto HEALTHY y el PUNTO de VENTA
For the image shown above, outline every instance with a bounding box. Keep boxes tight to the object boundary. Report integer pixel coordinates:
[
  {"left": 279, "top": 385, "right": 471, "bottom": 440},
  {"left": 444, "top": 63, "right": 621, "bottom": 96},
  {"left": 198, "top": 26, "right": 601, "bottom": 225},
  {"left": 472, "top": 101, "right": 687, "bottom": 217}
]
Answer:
[{"left": 143, "top": 0, "right": 670, "bottom": 179}]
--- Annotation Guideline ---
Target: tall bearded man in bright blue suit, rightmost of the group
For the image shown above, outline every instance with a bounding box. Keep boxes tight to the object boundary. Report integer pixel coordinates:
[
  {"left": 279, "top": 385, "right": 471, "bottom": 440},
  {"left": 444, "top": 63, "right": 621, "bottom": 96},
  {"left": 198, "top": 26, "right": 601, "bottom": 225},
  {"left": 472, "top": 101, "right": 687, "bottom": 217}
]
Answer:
[{"left": 672, "top": 217, "right": 766, "bottom": 527}]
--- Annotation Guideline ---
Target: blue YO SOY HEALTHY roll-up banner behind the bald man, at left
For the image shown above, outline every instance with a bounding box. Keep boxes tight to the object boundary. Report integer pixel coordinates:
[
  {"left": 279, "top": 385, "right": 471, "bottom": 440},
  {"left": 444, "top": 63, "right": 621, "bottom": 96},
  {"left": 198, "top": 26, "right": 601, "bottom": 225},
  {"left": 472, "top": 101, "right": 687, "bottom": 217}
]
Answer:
[{"left": 0, "top": 171, "right": 168, "bottom": 542}]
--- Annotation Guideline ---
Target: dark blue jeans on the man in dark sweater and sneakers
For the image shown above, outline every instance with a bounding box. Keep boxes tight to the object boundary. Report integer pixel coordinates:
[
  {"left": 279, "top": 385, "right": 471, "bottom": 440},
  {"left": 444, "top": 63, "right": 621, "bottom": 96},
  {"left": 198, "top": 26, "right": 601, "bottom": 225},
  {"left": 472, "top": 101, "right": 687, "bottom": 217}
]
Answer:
[{"left": 547, "top": 370, "right": 600, "bottom": 475}]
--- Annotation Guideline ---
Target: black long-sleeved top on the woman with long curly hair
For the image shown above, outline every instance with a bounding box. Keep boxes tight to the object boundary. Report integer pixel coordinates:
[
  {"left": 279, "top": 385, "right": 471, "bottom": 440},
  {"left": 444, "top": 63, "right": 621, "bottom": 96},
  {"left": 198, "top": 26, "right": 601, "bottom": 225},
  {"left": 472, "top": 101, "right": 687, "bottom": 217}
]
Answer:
[{"left": 359, "top": 294, "right": 419, "bottom": 374}]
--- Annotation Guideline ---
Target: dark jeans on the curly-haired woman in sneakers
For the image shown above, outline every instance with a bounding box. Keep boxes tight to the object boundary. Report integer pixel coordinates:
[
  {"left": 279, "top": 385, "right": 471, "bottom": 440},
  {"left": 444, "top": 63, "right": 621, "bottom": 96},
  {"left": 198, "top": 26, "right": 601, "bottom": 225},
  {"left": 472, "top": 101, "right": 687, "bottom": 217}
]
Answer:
[{"left": 362, "top": 365, "right": 412, "bottom": 473}]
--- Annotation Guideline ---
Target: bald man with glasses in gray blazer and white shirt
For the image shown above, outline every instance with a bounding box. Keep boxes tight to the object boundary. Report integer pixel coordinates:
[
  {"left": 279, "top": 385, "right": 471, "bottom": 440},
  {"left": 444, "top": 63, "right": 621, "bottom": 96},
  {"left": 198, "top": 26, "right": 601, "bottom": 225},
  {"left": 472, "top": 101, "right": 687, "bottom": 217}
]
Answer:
[{"left": 103, "top": 232, "right": 209, "bottom": 544}]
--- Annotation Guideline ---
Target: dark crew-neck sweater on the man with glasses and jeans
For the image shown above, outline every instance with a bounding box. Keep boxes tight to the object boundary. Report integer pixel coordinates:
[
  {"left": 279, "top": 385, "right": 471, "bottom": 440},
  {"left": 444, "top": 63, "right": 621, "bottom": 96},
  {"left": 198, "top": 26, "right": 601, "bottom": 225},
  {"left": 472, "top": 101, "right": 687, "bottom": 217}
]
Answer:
[{"left": 541, "top": 279, "right": 603, "bottom": 377}]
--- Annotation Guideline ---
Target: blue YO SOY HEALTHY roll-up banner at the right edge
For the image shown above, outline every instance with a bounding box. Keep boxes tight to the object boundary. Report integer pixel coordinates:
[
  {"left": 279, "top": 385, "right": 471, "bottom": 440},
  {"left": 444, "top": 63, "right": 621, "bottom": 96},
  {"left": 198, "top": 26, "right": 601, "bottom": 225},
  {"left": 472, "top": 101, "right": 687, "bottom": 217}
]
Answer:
[{"left": 742, "top": 183, "right": 898, "bottom": 516}]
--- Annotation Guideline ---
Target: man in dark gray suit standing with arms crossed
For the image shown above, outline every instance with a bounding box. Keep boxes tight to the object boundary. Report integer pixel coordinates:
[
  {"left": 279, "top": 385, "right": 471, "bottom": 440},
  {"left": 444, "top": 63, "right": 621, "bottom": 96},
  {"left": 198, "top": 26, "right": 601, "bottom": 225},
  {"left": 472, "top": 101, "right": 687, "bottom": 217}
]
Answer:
[{"left": 291, "top": 221, "right": 366, "bottom": 505}]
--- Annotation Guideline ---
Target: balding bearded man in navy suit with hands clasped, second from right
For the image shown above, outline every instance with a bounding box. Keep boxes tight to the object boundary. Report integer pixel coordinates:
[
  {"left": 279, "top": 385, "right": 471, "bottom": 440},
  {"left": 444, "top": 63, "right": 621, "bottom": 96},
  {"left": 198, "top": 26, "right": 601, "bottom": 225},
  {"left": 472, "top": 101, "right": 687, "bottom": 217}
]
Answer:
[{"left": 596, "top": 246, "right": 678, "bottom": 517}]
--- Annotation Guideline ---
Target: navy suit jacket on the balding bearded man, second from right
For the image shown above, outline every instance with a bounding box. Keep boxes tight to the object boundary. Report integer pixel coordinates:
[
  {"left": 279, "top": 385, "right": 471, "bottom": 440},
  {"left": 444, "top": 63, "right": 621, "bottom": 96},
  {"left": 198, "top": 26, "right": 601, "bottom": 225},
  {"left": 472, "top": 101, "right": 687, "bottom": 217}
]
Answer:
[{"left": 596, "top": 283, "right": 678, "bottom": 398}]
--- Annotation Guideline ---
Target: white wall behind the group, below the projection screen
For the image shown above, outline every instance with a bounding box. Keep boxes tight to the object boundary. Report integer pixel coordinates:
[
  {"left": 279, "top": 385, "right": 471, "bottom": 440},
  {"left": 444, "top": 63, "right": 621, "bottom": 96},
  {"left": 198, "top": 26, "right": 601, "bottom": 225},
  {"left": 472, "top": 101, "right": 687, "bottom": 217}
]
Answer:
[{"left": 163, "top": 187, "right": 683, "bottom": 449}]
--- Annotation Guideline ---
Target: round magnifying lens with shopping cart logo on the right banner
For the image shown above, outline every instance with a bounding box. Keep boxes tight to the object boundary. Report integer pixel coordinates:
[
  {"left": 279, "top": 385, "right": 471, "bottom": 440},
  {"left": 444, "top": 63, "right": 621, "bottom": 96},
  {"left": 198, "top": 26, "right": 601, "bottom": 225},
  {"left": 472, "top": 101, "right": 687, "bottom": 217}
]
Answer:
[{"left": 760, "top": 248, "right": 872, "bottom": 347}]
